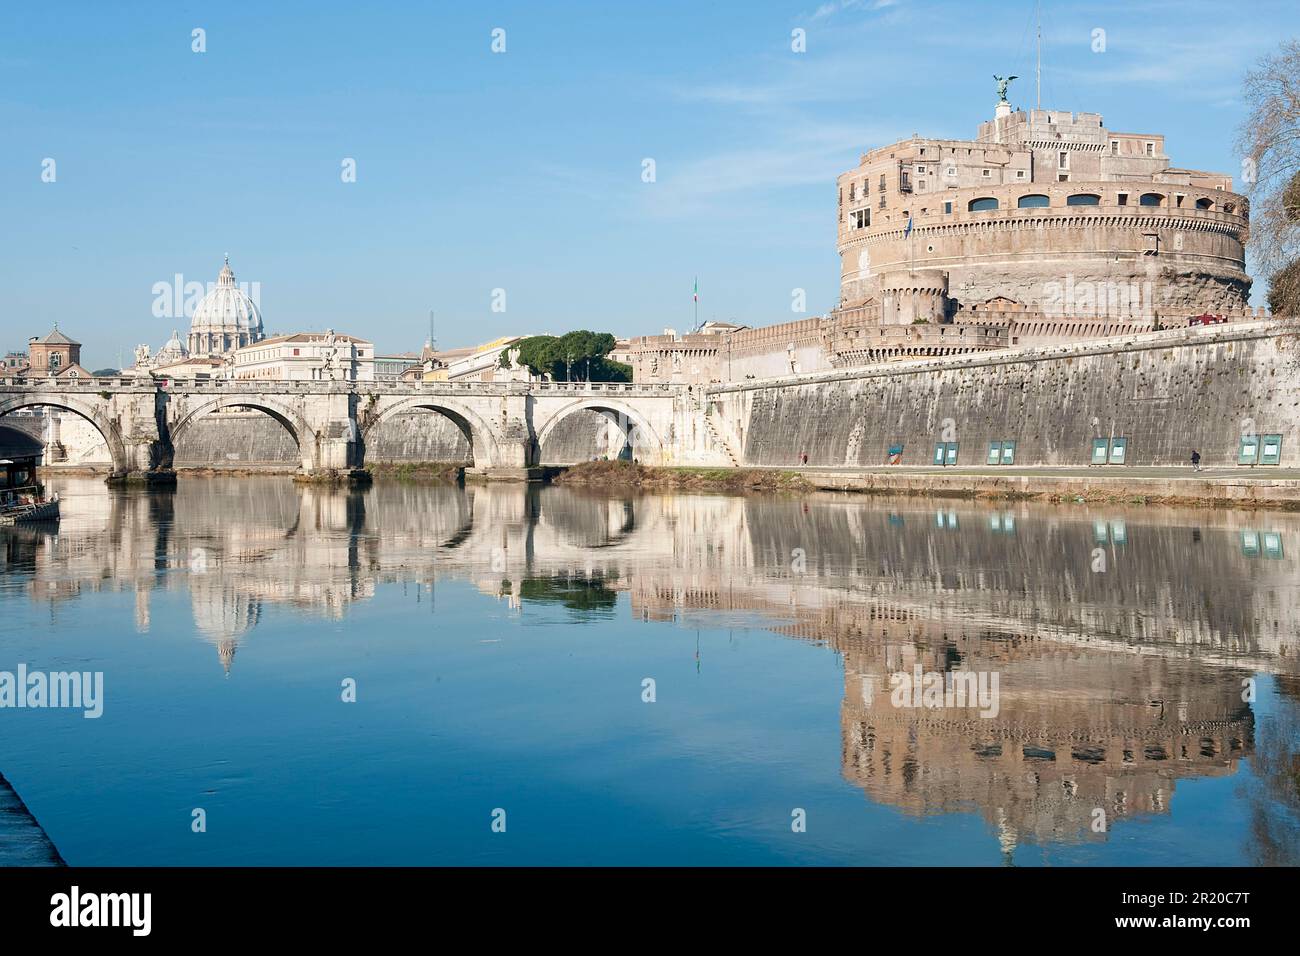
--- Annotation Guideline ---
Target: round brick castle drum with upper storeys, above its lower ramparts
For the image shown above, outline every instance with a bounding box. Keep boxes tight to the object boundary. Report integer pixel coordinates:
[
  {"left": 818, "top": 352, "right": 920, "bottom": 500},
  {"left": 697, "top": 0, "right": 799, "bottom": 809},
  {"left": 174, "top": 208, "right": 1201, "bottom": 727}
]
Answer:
[{"left": 839, "top": 104, "right": 1251, "bottom": 323}]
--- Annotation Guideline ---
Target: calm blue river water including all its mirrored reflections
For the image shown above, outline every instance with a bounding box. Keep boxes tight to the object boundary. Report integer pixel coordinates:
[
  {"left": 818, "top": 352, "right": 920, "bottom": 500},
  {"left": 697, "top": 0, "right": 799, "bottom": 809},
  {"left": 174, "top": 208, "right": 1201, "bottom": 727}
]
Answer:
[{"left": 0, "top": 477, "right": 1300, "bottom": 866}]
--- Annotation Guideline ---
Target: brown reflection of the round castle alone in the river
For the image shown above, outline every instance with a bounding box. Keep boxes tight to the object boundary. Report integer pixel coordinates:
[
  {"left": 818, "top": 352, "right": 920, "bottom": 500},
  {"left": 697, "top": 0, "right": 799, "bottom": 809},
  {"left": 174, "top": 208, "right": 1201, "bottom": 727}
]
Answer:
[{"left": 836, "top": 624, "right": 1253, "bottom": 849}]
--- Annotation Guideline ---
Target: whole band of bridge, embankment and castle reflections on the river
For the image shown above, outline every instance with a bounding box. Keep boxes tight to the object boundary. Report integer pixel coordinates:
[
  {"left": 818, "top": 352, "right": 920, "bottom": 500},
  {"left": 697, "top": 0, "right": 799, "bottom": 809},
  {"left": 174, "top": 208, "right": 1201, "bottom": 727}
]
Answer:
[{"left": 5, "top": 479, "right": 1300, "bottom": 851}]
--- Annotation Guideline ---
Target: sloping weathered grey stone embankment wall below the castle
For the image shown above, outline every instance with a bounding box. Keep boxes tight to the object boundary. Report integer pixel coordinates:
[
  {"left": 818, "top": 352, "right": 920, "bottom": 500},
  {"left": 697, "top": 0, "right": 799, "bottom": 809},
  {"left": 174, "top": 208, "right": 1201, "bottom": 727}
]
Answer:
[{"left": 706, "top": 319, "right": 1300, "bottom": 477}]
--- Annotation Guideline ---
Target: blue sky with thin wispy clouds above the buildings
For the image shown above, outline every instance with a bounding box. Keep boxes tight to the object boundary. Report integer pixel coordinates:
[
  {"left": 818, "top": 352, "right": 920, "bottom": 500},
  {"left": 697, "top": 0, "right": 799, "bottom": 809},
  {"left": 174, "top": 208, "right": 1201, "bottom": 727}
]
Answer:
[{"left": 0, "top": 0, "right": 1300, "bottom": 368}]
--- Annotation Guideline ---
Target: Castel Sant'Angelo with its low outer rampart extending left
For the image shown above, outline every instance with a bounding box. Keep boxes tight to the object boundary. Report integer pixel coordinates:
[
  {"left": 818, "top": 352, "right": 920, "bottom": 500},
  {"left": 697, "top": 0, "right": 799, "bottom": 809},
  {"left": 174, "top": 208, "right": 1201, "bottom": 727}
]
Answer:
[{"left": 629, "top": 78, "right": 1253, "bottom": 382}]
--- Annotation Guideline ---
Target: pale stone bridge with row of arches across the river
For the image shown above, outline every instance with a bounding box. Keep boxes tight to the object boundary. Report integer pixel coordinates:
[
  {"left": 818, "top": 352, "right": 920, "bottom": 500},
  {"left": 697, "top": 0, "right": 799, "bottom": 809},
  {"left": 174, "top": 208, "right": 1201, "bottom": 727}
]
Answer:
[{"left": 0, "top": 377, "right": 733, "bottom": 480}]
